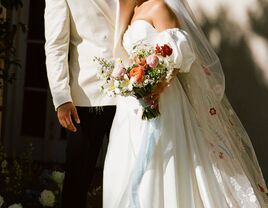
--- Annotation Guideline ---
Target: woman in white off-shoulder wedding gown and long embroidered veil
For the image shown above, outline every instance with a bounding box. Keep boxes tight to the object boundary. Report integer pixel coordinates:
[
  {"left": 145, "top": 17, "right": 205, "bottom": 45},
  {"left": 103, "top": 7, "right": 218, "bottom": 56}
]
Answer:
[{"left": 103, "top": 0, "right": 268, "bottom": 208}]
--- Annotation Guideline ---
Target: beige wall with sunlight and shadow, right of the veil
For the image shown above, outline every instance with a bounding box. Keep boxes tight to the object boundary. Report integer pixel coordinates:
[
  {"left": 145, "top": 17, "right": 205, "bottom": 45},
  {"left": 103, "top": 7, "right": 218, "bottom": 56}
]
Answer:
[{"left": 188, "top": 0, "right": 268, "bottom": 181}]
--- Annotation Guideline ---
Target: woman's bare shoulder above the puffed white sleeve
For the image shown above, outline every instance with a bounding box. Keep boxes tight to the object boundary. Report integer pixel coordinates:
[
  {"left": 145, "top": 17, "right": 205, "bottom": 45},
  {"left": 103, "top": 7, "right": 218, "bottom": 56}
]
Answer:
[{"left": 151, "top": 0, "right": 180, "bottom": 31}]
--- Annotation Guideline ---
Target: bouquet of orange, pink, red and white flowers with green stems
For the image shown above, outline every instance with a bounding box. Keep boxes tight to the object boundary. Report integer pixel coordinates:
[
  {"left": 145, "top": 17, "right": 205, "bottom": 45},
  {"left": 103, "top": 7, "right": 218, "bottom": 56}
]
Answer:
[{"left": 94, "top": 44, "right": 174, "bottom": 119}]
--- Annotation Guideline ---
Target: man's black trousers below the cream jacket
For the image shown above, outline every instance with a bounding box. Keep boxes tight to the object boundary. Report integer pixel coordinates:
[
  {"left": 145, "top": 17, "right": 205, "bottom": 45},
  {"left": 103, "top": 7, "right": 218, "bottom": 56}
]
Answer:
[{"left": 62, "top": 106, "right": 115, "bottom": 208}]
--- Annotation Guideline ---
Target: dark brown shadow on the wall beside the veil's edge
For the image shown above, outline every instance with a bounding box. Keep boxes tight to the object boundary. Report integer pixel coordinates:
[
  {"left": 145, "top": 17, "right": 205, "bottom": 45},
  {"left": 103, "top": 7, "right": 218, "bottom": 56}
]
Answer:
[{"left": 202, "top": 0, "right": 268, "bottom": 182}]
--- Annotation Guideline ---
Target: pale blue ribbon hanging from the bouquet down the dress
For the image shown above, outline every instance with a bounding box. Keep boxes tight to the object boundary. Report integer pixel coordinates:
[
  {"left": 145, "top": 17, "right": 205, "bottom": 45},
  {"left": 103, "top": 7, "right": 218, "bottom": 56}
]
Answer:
[{"left": 119, "top": 118, "right": 161, "bottom": 208}]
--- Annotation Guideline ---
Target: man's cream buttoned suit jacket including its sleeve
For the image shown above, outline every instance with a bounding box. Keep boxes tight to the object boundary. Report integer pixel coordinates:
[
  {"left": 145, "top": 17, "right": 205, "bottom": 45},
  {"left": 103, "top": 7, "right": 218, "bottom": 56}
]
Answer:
[{"left": 44, "top": 0, "right": 126, "bottom": 108}]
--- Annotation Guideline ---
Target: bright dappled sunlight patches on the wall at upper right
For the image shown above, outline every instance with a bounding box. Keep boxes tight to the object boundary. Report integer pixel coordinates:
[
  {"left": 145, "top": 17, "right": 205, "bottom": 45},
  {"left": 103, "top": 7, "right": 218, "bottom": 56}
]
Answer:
[{"left": 188, "top": 0, "right": 268, "bottom": 85}]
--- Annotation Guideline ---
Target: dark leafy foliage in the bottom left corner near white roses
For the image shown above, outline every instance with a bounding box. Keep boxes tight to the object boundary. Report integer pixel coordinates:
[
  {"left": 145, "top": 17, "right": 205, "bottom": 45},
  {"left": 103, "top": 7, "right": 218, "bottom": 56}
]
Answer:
[{"left": 0, "top": 143, "right": 64, "bottom": 208}]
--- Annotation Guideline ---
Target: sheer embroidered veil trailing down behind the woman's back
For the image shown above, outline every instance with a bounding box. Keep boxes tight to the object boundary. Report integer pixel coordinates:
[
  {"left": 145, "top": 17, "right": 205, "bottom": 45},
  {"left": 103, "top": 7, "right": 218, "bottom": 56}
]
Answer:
[{"left": 168, "top": 0, "right": 265, "bottom": 184}]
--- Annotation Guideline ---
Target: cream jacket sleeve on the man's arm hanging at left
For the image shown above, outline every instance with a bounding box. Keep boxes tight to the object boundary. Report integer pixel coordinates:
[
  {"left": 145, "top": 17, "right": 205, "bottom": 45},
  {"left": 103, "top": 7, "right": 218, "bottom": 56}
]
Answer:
[{"left": 44, "top": 0, "right": 72, "bottom": 109}]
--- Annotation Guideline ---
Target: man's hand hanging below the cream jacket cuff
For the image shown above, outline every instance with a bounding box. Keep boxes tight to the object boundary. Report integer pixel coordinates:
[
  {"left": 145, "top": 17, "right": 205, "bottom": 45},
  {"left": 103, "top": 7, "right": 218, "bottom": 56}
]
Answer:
[{"left": 57, "top": 102, "right": 80, "bottom": 132}]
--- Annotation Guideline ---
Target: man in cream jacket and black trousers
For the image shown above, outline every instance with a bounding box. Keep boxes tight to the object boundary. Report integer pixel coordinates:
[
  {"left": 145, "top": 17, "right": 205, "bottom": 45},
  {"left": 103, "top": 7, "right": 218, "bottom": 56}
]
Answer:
[{"left": 45, "top": 0, "right": 133, "bottom": 208}]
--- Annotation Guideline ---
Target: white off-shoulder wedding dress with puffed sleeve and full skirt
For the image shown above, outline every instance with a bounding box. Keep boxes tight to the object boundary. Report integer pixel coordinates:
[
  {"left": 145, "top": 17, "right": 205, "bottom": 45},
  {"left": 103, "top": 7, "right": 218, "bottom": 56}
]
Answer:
[{"left": 103, "top": 20, "right": 267, "bottom": 208}]
